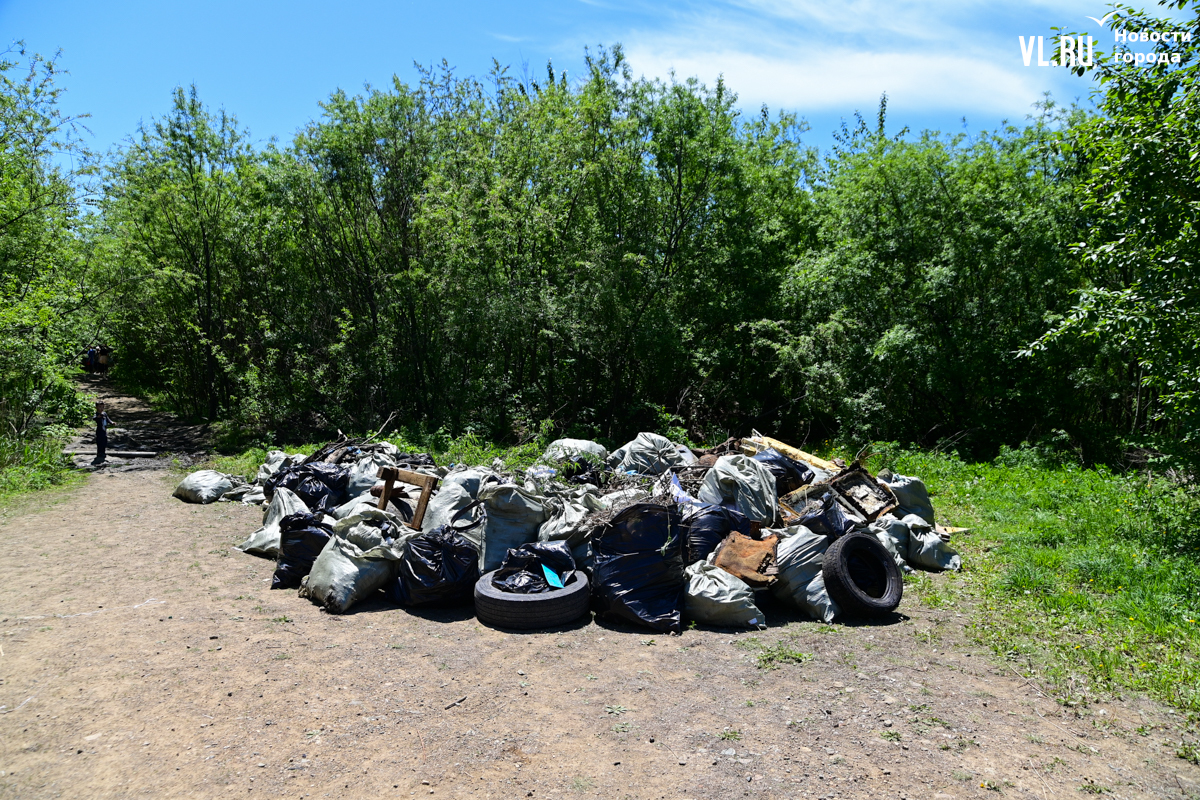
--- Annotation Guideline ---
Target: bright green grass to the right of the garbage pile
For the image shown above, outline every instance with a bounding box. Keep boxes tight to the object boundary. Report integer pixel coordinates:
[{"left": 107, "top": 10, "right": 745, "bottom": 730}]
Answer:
[{"left": 870, "top": 447, "right": 1200, "bottom": 711}]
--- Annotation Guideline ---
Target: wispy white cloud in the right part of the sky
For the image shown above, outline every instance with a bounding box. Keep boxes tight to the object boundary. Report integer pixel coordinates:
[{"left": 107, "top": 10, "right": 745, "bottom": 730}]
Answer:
[{"left": 624, "top": 0, "right": 1103, "bottom": 116}]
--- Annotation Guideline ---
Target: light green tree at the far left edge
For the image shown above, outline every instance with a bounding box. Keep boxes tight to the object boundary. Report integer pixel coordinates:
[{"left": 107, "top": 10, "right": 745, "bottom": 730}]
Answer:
[{"left": 0, "top": 43, "right": 91, "bottom": 455}]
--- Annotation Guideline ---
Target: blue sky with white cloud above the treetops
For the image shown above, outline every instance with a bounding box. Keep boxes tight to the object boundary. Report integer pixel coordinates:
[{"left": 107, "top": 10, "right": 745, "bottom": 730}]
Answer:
[{"left": 0, "top": 0, "right": 1156, "bottom": 151}]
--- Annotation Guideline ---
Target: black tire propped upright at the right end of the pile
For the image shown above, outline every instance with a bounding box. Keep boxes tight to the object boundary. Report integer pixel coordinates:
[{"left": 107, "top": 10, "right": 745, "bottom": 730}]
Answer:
[{"left": 821, "top": 534, "right": 904, "bottom": 616}]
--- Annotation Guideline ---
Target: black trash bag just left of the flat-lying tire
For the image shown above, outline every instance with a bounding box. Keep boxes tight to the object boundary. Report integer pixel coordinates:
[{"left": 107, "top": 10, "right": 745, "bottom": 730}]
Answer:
[{"left": 386, "top": 527, "right": 479, "bottom": 607}]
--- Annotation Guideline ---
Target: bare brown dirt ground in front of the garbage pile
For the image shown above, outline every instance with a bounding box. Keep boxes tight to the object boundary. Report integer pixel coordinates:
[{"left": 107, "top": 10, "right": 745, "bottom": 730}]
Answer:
[{"left": 0, "top": 393, "right": 1200, "bottom": 800}]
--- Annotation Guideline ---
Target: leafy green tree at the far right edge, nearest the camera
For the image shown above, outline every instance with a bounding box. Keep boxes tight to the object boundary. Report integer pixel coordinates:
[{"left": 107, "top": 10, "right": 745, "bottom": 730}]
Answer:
[{"left": 1031, "top": 0, "right": 1200, "bottom": 458}]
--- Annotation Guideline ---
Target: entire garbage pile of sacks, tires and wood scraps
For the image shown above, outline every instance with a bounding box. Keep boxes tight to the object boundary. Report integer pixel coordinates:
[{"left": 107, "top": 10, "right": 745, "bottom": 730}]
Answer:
[{"left": 174, "top": 433, "right": 961, "bottom": 633}]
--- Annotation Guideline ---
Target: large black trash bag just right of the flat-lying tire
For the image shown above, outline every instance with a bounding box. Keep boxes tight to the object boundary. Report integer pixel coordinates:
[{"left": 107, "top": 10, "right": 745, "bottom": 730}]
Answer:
[{"left": 592, "top": 503, "right": 688, "bottom": 633}]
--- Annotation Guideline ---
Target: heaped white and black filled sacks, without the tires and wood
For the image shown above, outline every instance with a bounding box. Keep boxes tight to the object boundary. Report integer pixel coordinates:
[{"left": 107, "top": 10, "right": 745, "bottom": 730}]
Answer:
[{"left": 205, "top": 433, "right": 961, "bottom": 631}]
